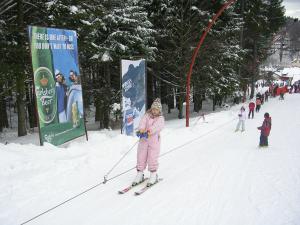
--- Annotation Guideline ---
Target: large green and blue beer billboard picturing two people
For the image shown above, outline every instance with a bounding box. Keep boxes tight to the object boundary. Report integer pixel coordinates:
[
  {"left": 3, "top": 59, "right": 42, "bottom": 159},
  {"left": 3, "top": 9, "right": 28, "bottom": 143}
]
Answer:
[{"left": 28, "top": 26, "right": 86, "bottom": 145}]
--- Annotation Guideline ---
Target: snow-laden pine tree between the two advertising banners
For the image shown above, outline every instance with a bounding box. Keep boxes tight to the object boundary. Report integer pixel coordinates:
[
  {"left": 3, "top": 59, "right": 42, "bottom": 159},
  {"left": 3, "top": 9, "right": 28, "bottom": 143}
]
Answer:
[{"left": 93, "top": 0, "right": 156, "bottom": 126}]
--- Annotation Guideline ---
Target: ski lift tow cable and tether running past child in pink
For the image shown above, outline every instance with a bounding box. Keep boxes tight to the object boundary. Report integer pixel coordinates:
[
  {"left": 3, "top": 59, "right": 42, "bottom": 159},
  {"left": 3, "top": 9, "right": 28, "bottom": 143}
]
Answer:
[{"left": 20, "top": 119, "right": 236, "bottom": 225}]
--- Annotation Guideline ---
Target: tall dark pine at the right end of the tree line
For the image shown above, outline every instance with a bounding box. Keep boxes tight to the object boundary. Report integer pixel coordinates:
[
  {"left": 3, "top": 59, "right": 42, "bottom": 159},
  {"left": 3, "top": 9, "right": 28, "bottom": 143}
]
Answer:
[{"left": 242, "top": 0, "right": 284, "bottom": 98}]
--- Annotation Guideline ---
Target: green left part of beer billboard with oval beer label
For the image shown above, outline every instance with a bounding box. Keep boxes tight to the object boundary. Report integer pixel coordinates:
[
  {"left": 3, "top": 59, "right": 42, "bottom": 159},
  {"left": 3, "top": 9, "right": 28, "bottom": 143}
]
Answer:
[{"left": 29, "top": 26, "right": 58, "bottom": 128}]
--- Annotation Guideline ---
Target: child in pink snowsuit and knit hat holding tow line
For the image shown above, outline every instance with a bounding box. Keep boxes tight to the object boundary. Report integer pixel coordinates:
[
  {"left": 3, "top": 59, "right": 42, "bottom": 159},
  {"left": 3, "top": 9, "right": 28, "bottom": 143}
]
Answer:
[{"left": 132, "top": 99, "right": 164, "bottom": 186}]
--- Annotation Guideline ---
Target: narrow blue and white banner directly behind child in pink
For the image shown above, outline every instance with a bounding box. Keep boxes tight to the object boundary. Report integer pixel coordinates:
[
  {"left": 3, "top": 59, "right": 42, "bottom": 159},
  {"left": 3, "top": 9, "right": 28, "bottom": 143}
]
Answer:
[{"left": 121, "top": 59, "right": 146, "bottom": 136}]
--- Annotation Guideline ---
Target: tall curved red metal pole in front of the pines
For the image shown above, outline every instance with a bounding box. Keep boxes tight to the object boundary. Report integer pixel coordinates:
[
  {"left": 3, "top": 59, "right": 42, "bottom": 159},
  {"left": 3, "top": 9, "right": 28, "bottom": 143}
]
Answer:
[{"left": 186, "top": 0, "right": 237, "bottom": 127}]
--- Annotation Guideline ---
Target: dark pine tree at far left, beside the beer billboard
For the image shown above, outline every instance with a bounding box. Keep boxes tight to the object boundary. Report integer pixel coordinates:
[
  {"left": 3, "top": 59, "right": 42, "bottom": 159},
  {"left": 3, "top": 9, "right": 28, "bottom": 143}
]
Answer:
[{"left": 0, "top": 0, "right": 46, "bottom": 136}]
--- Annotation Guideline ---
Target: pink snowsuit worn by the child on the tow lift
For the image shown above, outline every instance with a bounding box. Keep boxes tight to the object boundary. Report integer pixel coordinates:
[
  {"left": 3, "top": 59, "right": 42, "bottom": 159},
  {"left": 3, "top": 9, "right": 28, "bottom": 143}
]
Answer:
[{"left": 136, "top": 114, "right": 164, "bottom": 172}]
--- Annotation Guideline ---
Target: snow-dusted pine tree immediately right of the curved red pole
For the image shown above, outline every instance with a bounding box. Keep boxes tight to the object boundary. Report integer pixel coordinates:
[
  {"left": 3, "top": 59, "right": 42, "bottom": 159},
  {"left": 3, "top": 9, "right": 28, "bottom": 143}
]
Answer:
[{"left": 196, "top": 2, "right": 243, "bottom": 111}]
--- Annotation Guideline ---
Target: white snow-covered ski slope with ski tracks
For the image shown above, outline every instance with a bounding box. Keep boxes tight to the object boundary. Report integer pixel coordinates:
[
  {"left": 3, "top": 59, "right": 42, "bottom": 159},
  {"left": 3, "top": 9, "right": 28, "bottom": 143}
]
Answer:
[{"left": 0, "top": 94, "right": 300, "bottom": 225}]
